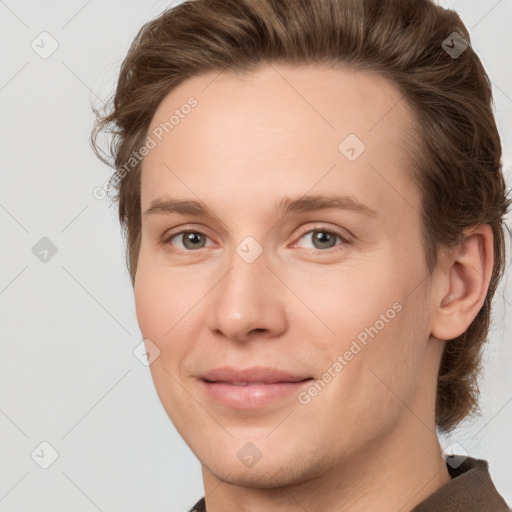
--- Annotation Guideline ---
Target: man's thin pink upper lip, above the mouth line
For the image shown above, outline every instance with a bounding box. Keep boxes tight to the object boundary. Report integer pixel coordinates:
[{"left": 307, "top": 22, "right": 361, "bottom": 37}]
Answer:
[{"left": 199, "top": 366, "right": 311, "bottom": 384}]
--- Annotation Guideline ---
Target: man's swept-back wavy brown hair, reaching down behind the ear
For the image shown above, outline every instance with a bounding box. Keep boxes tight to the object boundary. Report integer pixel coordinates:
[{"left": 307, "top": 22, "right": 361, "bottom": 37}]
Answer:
[{"left": 91, "top": 0, "right": 510, "bottom": 433}]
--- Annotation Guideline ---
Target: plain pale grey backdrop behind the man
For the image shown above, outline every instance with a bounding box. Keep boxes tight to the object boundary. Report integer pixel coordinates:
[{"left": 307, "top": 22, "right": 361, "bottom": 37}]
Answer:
[{"left": 0, "top": 0, "right": 512, "bottom": 512}]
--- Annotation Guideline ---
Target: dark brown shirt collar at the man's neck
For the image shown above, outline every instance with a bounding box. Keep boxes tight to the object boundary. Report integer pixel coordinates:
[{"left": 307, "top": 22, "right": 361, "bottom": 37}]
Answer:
[{"left": 189, "top": 457, "right": 512, "bottom": 512}]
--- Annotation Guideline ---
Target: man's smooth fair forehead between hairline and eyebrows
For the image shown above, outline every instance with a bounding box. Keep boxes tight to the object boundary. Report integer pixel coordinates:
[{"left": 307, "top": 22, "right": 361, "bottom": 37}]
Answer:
[{"left": 142, "top": 64, "right": 415, "bottom": 218}]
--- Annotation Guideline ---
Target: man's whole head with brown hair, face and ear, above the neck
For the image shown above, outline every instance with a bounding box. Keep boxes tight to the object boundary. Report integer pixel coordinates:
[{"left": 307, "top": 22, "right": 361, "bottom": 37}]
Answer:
[{"left": 92, "top": 0, "right": 509, "bottom": 488}]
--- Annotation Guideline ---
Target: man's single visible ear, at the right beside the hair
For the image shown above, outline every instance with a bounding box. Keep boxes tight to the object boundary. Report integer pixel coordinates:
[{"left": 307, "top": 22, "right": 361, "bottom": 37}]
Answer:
[{"left": 431, "top": 224, "right": 494, "bottom": 340}]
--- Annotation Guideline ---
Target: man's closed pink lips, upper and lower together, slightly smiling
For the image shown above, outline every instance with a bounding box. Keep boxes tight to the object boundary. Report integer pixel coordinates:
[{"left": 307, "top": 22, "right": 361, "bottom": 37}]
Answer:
[{"left": 199, "top": 366, "right": 312, "bottom": 410}]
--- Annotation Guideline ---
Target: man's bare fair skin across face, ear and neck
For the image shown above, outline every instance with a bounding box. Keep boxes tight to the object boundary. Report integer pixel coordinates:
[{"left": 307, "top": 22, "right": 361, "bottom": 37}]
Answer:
[{"left": 135, "top": 65, "right": 493, "bottom": 512}]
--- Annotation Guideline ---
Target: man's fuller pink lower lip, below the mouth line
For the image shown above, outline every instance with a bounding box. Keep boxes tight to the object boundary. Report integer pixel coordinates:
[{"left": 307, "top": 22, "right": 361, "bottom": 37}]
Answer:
[{"left": 200, "top": 379, "right": 312, "bottom": 409}]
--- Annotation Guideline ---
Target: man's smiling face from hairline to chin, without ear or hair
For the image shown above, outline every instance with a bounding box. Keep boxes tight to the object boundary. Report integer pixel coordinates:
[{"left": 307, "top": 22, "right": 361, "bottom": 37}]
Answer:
[{"left": 135, "top": 66, "right": 442, "bottom": 486}]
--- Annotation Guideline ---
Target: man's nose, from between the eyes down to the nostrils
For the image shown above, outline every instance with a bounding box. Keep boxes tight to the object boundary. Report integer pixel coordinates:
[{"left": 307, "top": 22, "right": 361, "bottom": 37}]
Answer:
[{"left": 207, "top": 246, "right": 287, "bottom": 341}]
